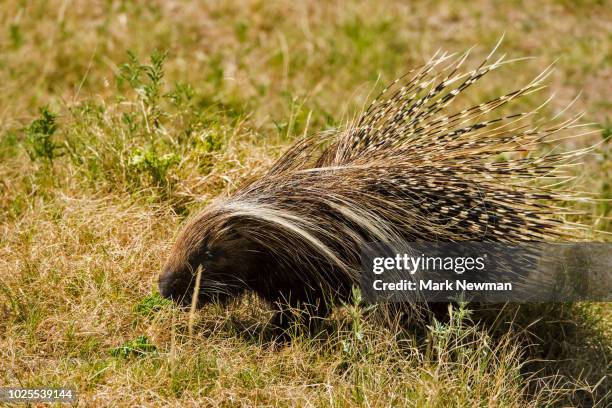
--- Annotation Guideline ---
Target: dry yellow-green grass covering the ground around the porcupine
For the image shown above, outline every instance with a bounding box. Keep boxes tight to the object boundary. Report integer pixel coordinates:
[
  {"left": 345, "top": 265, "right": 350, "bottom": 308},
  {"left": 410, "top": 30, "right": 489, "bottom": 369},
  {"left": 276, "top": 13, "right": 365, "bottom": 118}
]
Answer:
[{"left": 0, "top": 0, "right": 612, "bottom": 407}]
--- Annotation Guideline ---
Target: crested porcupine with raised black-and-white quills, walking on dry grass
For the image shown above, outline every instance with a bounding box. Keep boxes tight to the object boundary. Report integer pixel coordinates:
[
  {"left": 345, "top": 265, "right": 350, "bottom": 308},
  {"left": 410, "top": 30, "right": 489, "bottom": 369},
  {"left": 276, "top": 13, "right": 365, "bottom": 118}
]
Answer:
[{"left": 159, "top": 47, "right": 592, "bottom": 324}]
